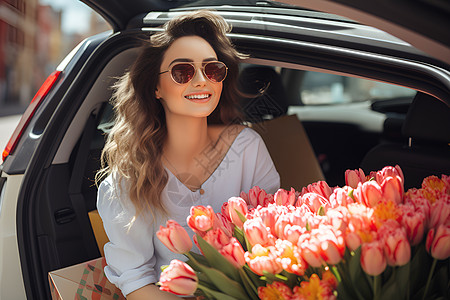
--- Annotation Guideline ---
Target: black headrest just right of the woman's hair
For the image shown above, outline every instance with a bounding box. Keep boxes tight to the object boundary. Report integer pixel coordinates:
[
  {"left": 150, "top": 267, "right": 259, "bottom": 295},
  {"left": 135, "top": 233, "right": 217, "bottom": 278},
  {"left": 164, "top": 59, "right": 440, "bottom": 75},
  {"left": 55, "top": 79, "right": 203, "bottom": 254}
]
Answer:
[{"left": 239, "top": 66, "right": 288, "bottom": 122}]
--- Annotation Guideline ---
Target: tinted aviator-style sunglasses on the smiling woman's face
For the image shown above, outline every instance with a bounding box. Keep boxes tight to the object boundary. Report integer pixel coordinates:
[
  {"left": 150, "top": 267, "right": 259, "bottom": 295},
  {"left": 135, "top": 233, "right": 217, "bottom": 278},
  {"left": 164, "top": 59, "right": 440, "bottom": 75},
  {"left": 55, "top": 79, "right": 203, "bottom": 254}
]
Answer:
[{"left": 159, "top": 61, "right": 228, "bottom": 84}]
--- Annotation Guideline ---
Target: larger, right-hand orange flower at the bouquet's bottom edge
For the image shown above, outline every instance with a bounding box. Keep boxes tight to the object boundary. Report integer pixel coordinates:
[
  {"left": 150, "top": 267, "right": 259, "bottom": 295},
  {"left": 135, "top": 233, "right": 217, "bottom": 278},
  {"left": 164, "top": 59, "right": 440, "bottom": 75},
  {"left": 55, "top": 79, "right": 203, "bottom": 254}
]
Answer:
[{"left": 292, "top": 272, "right": 336, "bottom": 300}]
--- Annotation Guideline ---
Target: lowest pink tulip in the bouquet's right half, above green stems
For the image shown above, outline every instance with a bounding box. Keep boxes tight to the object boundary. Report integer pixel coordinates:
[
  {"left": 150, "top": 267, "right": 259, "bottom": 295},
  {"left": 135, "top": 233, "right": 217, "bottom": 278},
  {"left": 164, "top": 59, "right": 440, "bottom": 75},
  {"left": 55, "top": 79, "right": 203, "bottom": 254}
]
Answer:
[{"left": 361, "top": 240, "right": 386, "bottom": 276}]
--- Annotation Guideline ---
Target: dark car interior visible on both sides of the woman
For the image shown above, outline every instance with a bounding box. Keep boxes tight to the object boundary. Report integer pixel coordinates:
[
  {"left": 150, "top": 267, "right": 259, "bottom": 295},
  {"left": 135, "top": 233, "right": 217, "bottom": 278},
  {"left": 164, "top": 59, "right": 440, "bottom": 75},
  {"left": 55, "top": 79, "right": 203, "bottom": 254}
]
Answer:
[{"left": 32, "top": 35, "right": 450, "bottom": 286}]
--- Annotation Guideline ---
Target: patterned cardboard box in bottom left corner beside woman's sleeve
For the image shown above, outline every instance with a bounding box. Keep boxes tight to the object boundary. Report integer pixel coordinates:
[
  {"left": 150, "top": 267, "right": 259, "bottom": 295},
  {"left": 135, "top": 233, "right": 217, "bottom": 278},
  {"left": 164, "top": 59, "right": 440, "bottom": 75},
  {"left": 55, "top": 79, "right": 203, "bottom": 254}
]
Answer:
[{"left": 48, "top": 257, "right": 125, "bottom": 300}]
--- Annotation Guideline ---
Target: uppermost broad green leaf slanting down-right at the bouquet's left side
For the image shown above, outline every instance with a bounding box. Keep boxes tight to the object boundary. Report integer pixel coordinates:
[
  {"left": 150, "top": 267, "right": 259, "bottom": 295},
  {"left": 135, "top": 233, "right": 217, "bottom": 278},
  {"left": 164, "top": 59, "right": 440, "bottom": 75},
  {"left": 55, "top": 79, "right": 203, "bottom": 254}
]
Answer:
[{"left": 197, "top": 234, "right": 240, "bottom": 281}]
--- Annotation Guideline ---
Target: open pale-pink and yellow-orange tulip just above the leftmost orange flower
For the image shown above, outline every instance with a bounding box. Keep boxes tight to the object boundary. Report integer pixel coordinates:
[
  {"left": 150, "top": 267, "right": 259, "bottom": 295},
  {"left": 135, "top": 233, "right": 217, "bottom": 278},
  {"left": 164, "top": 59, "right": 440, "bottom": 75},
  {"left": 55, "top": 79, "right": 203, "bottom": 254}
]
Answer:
[{"left": 244, "top": 244, "right": 283, "bottom": 276}]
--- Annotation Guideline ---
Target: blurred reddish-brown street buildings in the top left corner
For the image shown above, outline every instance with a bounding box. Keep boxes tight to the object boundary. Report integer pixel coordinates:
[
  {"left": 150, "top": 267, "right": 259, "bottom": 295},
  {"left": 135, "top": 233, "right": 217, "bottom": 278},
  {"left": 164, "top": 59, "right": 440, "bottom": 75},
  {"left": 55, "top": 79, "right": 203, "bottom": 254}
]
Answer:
[{"left": 0, "top": 0, "right": 110, "bottom": 116}]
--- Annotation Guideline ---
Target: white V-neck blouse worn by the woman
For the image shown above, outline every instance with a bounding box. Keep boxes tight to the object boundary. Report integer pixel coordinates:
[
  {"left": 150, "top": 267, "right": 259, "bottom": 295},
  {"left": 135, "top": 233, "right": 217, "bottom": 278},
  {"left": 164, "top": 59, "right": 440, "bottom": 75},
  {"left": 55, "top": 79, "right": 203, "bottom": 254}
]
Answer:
[{"left": 97, "top": 128, "right": 280, "bottom": 295}]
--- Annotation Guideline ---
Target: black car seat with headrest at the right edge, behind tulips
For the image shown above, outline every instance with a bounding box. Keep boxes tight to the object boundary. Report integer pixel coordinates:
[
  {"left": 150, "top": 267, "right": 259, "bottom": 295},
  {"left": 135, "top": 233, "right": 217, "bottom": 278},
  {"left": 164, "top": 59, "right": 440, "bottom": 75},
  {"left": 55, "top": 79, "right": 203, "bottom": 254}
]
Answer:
[{"left": 361, "top": 92, "right": 450, "bottom": 189}]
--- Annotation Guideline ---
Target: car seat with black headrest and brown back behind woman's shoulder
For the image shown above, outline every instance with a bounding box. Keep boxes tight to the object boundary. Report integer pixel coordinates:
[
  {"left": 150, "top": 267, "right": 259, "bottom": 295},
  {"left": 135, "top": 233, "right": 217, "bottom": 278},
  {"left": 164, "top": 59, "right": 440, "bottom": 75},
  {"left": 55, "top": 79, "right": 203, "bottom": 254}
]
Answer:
[{"left": 239, "top": 66, "right": 324, "bottom": 190}]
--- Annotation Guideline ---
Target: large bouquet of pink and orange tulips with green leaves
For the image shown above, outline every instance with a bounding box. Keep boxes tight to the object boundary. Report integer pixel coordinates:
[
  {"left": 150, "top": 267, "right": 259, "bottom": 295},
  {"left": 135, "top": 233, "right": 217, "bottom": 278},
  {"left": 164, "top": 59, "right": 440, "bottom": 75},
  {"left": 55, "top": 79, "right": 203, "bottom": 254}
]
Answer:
[{"left": 157, "top": 166, "right": 450, "bottom": 300}]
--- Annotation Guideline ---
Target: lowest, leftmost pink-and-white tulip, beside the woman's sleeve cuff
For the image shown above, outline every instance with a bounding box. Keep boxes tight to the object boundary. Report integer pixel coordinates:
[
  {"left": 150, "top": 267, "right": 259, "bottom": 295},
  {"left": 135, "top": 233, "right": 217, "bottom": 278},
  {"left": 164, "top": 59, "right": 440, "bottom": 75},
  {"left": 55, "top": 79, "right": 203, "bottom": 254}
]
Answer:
[{"left": 159, "top": 259, "right": 198, "bottom": 295}]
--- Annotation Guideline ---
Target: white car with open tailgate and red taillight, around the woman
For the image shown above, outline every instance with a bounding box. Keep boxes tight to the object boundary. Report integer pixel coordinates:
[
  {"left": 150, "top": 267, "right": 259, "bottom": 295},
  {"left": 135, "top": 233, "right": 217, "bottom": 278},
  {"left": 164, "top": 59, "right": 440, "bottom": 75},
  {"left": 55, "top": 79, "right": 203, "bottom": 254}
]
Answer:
[{"left": 0, "top": 0, "right": 450, "bottom": 299}]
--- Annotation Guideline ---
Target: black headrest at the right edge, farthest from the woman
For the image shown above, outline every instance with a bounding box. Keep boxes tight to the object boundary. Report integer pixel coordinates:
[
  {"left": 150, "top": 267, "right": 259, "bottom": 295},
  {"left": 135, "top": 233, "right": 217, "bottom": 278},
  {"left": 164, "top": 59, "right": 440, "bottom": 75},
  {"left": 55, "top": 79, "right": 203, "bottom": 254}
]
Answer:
[{"left": 402, "top": 92, "right": 450, "bottom": 144}]
